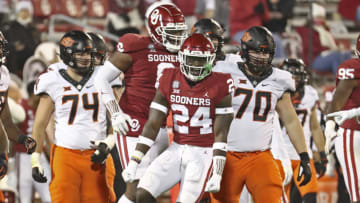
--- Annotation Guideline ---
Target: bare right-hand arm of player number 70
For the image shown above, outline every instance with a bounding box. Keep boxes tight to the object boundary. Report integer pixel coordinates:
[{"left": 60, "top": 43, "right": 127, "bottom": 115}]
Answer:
[{"left": 276, "top": 92, "right": 307, "bottom": 154}]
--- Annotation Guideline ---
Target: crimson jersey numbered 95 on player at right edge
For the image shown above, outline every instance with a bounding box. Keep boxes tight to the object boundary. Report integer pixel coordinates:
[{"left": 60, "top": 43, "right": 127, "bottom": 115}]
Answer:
[{"left": 336, "top": 58, "right": 360, "bottom": 130}]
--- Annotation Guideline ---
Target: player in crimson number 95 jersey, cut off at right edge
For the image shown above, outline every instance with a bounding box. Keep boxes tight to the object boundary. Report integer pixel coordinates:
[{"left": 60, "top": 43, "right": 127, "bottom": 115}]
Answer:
[{"left": 325, "top": 35, "right": 360, "bottom": 202}]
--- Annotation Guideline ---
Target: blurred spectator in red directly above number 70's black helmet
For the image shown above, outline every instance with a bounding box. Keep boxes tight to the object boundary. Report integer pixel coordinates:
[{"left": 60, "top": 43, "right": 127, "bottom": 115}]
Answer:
[{"left": 229, "top": 0, "right": 270, "bottom": 43}]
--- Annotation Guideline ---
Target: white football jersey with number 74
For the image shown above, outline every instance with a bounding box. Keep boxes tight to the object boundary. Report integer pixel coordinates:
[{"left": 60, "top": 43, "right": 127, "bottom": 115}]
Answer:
[{"left": 34, "top": 63, "right": 106, "bottom": 150}]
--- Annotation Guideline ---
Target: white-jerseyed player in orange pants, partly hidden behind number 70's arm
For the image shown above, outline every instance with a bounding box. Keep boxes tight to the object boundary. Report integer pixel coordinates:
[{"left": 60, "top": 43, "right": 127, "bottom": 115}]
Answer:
[{"left": 280, "top": 58, "right": 327, "bottom": 203}]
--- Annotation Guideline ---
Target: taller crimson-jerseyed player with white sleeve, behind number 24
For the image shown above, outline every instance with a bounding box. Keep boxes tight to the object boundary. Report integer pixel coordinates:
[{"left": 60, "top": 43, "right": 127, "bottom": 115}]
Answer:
[{"left": 95, "top": 4, "right": 187, "bottom": 203}]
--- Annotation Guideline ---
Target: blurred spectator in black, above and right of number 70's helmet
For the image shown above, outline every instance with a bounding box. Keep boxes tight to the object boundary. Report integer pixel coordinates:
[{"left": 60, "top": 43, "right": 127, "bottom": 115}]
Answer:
[{"left": 264, "top": 0, "right": 295, "bottom": 58}]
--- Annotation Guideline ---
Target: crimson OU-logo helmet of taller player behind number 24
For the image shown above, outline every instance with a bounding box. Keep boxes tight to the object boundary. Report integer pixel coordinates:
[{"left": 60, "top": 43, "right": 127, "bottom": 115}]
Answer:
[{"left": 145, "top": 4, "right": 187, "bottom": 52}]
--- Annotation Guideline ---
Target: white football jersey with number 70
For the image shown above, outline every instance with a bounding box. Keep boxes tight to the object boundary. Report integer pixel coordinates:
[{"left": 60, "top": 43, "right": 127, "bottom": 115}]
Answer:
[{"left": 213, "top": 61, "right": 295, "bottom": 152}]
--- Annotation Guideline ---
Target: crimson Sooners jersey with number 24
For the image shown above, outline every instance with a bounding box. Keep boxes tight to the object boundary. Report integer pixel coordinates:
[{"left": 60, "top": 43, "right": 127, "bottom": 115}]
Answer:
[{"left": 159, "top": 68, "right": 234, "bottom": 147}]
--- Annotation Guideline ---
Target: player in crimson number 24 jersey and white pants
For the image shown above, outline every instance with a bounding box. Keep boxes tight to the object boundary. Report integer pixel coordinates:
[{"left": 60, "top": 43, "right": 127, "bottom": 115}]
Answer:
[{"left": 123, "top": 33, "right": 233, "bottom": 203}]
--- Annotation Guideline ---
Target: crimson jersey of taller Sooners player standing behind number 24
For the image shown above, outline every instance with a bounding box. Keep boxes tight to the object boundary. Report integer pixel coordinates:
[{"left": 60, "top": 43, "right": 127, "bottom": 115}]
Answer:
[{"left": 117, "top": 34, "right": 179, "bottom": 136}]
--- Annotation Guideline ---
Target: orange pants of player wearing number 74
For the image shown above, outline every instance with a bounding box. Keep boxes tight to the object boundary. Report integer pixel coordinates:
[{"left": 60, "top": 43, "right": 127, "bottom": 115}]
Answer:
[{"left": 49, "top": 145, "right": 109, "bottom": 203}]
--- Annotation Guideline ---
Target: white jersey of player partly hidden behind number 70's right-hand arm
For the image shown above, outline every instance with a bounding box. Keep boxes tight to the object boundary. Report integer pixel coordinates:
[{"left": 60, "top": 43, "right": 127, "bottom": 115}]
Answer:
[{"left": 283, "top": 85, "right": 319, "bottom": 160}]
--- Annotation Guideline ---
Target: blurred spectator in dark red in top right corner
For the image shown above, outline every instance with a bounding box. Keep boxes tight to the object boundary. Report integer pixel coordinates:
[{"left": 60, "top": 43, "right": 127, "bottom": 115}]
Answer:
[{"left": 338, "top": 0, "right": 360, "bottom": 24}]
